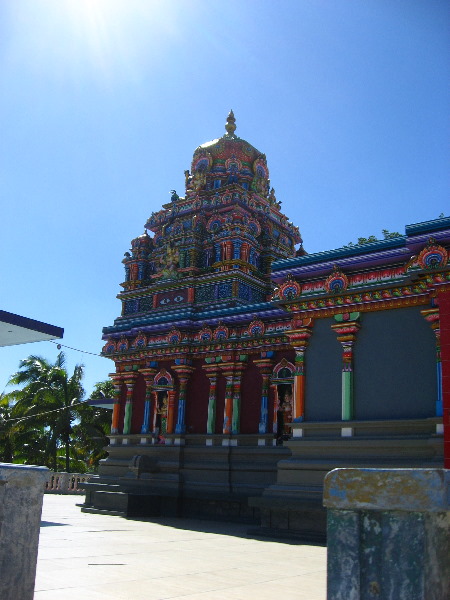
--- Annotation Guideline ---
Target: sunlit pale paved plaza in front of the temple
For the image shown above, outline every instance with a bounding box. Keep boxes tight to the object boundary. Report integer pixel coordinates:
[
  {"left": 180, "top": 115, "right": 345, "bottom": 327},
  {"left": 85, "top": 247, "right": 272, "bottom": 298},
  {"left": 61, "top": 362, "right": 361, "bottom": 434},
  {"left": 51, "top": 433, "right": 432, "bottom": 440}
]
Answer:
[{"left": 34, "top": 495, "right": 326, "bottom": 600}]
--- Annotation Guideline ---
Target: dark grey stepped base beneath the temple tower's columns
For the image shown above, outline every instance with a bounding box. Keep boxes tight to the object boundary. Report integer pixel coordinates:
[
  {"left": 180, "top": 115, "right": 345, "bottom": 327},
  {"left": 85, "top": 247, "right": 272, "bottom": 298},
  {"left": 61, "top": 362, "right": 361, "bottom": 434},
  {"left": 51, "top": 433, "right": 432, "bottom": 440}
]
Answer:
[{"left": 82, "top": 435, "right": 290, "bottom": 524}]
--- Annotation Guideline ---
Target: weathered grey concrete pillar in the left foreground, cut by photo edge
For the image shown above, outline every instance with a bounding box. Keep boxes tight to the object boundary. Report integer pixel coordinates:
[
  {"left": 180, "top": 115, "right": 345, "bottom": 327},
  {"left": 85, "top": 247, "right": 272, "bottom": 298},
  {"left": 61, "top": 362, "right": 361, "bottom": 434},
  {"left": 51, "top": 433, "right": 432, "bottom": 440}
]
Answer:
[{"left": 0, "top": 463, "right": 48, "bottom": 600}]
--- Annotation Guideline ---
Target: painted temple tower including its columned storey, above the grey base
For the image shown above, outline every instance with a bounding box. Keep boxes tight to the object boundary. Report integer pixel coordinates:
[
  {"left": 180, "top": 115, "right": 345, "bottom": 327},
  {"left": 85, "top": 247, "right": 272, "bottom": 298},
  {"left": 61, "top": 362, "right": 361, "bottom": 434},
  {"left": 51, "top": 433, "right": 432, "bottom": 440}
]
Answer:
[{"left": 103, "top": 111, "right": 302, "bottom": 439}]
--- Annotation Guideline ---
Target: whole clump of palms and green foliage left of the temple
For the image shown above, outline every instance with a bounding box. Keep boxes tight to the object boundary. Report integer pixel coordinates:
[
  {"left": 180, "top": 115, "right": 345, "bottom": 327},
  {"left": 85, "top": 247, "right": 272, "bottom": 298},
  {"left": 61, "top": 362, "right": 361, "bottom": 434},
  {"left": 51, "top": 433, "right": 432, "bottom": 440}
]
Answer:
[{"left": 0, "top": 352, "right": 114, "bottom": 473}]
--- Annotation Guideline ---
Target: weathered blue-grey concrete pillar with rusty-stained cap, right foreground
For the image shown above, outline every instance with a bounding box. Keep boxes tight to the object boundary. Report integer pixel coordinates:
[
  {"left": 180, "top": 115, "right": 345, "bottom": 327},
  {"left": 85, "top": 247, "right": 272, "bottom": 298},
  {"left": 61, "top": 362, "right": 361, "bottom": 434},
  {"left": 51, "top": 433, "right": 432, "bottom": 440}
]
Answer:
[{"left": 324, "top": 469, "right": 450, "bottom": 600}]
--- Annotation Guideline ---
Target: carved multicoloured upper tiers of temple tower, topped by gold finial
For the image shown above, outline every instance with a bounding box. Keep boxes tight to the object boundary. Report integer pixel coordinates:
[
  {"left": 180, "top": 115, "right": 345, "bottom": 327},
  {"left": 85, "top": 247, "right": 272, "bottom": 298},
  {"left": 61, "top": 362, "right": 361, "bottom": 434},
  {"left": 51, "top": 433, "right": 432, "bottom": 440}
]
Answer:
[{"left": 120, "top": 111, "right": 301, "bottom": 318}]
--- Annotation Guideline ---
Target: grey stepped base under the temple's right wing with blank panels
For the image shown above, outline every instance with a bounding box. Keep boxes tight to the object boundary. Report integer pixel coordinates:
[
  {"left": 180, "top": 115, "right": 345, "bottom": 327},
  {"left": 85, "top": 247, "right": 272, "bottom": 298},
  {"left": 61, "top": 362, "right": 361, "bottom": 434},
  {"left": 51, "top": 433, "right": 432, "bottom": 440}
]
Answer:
[{"left": 249, "top": 418, "right": 443, "bottom": 541}]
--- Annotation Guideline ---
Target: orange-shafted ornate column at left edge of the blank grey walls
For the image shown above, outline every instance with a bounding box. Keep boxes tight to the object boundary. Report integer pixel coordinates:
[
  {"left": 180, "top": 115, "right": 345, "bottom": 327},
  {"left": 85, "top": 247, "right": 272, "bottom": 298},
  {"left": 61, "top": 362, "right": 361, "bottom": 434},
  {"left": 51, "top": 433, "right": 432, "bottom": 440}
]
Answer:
[{"left": 286, "top": 319, "right": 314, "bottom": 423}]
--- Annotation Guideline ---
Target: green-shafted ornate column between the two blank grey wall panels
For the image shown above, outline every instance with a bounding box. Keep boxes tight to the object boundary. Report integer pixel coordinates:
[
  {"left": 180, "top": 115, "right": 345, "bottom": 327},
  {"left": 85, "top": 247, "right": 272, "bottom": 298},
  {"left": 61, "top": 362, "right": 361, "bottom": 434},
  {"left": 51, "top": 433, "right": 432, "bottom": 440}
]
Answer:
[{"left": 331, "top": 312, "right": 361, "bottom": 421}]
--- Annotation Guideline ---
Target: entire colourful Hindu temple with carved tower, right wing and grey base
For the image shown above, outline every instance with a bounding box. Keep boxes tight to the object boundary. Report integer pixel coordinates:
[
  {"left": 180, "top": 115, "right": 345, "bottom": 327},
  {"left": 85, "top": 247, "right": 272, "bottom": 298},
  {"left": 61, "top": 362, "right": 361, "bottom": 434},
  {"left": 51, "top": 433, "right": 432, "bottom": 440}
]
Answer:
[{"left": 83, "top": 111, "right": 450, "bottom": 538}]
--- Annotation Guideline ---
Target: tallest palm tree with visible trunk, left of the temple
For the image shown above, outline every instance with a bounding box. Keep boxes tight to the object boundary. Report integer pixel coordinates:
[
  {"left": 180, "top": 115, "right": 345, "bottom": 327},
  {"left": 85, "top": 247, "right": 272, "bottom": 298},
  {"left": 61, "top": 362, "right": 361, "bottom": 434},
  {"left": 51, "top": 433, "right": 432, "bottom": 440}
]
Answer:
[{"left": 9, "top": 352, "right": 84, "bottom": 471}]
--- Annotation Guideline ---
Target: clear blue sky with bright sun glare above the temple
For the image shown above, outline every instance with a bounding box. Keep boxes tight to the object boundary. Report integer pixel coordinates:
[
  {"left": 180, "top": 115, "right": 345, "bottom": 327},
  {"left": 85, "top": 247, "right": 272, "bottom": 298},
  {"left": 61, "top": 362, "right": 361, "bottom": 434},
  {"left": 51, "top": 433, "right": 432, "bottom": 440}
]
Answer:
[{"left": 0, "top": 0, "right": 450, "bottom": 392}]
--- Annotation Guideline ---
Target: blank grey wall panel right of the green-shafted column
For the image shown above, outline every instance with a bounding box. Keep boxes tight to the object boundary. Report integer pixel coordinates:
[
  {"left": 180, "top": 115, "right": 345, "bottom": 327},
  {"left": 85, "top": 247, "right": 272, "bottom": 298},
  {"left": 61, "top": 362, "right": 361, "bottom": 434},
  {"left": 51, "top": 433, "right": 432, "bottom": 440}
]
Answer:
[{"left": 354, "top": 307, "right": 437, "bottom": 420}]
